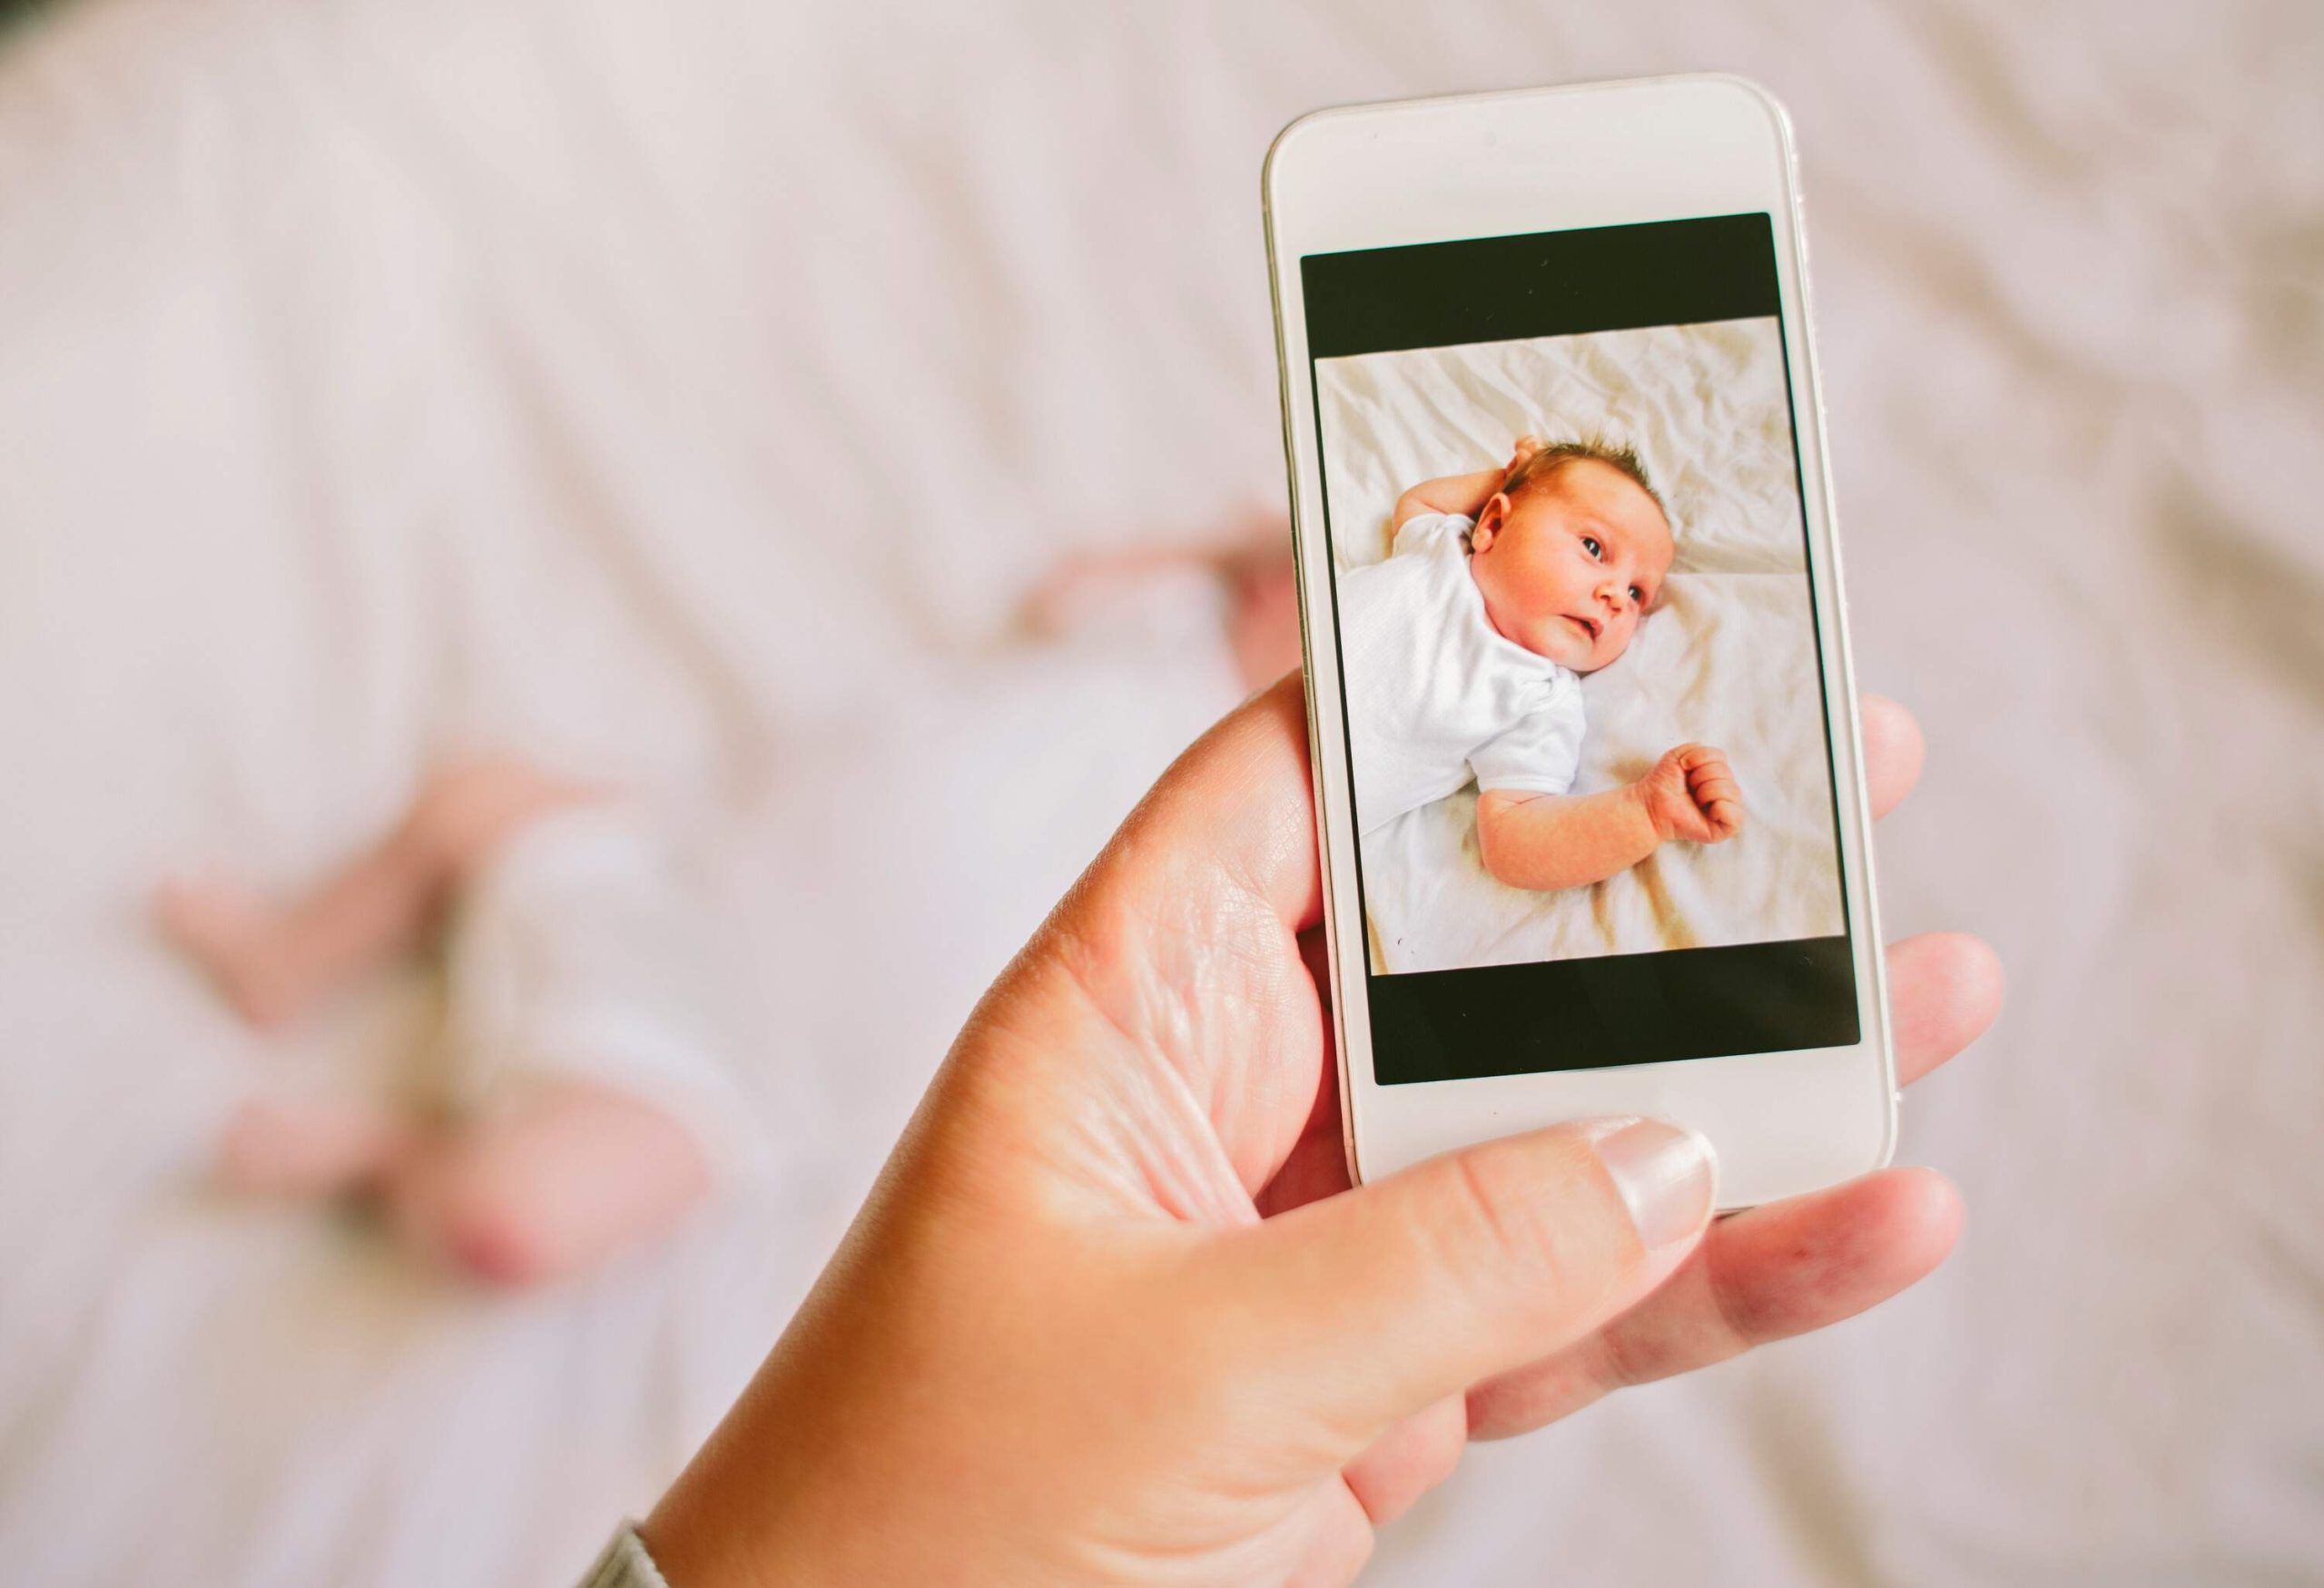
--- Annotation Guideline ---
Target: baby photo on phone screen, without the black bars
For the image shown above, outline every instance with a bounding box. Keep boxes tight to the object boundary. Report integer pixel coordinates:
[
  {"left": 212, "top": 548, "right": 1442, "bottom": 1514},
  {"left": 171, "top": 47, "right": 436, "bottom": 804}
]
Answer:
[{"left": 1315, "top": 316, "right": 1841, "bottom": 974}]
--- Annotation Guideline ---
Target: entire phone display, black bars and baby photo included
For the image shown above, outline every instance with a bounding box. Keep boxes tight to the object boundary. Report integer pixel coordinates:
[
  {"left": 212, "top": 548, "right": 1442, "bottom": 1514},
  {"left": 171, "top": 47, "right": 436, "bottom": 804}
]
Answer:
[{"left": 1299, "top": 214, "right": 1859, "bottom": 1086}]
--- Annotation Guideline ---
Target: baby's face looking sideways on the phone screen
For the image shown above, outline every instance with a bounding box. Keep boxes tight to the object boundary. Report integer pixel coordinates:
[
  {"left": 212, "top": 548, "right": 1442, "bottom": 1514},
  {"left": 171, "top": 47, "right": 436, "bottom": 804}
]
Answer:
[{"left": 1469, "top": 458, "right": 1671, "bottom": 672}]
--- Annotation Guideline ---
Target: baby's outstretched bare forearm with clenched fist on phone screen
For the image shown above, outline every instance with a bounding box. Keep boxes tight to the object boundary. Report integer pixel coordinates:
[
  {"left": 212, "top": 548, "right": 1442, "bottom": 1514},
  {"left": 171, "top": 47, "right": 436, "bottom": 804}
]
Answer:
[{"left": 1476, "top": 744, "right": 1743, "bottom": 891}]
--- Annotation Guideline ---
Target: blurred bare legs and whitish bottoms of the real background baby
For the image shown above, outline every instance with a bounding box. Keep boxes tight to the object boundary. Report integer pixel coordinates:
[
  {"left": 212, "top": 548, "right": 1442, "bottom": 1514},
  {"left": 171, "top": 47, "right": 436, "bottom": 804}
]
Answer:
[{"left": 156, "top": 758, "right": 748, "bottom": 1286}]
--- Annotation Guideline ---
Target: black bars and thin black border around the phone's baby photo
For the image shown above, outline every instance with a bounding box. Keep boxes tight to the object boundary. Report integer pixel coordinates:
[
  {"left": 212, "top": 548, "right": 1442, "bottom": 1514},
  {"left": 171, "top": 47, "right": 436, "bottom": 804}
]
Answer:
[{"left": 1299, "top": 212, "right": 1864, "bottom": 1086}]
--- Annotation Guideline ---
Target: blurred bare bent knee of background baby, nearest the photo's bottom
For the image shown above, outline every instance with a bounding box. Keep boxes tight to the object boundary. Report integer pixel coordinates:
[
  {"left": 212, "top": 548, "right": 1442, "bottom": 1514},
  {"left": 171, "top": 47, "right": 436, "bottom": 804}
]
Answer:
[{"left": 381, "top": 1079, "right": 711, "bottom": 1286}]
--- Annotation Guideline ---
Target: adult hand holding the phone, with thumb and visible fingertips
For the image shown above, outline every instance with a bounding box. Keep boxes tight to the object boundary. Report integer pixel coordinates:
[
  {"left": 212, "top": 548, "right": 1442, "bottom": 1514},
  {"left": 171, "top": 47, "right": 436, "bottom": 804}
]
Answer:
[{"left": 644, "top": 679, "right": 1999, "bottom": 1588}]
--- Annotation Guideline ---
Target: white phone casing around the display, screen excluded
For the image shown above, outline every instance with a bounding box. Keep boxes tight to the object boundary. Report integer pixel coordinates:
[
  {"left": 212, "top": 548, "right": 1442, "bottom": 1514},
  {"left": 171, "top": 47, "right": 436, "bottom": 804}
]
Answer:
[{"left": 1262, "top": 74, "right": 1896, "bottom": 1207}]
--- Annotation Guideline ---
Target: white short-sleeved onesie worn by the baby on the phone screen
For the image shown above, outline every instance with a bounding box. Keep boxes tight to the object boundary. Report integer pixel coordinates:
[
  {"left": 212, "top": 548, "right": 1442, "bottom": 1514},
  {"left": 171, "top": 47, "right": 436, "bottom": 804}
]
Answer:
[{"left": 1339, "top": 514, "right": 1582, "bottom": 833}]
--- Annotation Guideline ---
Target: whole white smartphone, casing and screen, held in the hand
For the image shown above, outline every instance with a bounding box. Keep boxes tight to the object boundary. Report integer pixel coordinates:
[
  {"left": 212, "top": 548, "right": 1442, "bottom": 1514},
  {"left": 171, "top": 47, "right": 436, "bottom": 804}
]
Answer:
[{"left": 1265, "top": 77, "right": 1896, "bottom": 1207}]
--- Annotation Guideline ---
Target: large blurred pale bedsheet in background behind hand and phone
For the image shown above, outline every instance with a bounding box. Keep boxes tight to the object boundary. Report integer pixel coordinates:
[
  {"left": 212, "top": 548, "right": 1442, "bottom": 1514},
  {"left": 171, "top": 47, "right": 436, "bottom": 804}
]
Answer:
[{"left": 0, "top": 0, "right": 2324, "bottom": 1588}]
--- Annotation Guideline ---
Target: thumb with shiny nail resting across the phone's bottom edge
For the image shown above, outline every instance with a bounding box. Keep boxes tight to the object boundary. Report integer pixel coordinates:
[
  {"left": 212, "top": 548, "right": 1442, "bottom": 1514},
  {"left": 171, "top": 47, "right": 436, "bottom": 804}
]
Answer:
[{"left": 1208, "top": 1119, "right": 1718, "bottom": 1448}]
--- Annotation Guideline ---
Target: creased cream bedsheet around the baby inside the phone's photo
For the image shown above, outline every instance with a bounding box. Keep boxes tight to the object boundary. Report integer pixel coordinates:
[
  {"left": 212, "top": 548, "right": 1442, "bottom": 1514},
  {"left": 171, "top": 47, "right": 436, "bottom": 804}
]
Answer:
[{"left": 1315, "top": 319, "right": 1843, "bottom": 972}]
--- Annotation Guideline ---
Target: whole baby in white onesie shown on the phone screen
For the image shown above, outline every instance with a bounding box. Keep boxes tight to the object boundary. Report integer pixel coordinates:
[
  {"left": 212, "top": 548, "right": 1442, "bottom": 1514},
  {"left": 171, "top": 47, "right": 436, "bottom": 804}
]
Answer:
[{"left": 1339, "top": 437, "right": 1743, "bottom": 888}]
